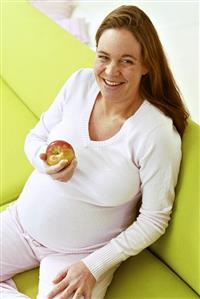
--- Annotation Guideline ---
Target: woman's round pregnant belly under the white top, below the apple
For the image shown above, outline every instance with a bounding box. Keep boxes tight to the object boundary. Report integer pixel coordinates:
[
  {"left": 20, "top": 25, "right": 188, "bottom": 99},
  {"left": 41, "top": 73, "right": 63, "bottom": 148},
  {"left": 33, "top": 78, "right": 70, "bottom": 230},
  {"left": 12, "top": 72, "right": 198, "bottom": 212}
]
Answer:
[{"left": 18, "top": 172, "right": 136, "bottom": 252}]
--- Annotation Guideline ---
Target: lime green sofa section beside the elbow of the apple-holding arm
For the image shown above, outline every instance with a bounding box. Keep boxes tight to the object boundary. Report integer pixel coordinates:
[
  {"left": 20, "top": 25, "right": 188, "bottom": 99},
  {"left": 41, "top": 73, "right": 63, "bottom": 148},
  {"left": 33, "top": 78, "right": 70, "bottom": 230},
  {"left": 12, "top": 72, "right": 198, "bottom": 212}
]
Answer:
[{"left": 0, "top": 80, "right": 37, "bottom": 205}]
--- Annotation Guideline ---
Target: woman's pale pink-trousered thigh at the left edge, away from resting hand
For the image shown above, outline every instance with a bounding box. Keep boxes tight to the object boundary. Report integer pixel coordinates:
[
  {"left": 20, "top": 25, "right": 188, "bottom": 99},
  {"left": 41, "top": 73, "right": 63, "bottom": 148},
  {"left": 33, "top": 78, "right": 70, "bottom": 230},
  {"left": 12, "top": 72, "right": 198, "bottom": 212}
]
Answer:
[{"left": 0, "top": 206, "right": 38, "bottom": 281}]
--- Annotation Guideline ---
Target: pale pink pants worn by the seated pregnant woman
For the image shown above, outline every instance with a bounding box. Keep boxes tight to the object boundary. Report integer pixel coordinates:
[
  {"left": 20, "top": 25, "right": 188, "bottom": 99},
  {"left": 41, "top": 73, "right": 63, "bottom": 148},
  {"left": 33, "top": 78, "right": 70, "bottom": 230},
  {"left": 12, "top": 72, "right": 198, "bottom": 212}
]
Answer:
[{"left": 0, "top": 204, "right": 117, "bottom": 299}]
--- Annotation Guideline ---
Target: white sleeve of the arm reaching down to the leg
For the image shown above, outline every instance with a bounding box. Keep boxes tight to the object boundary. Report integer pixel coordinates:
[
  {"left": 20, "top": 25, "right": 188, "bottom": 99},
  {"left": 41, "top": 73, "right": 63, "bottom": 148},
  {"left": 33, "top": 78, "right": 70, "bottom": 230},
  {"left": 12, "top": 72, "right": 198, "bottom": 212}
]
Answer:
[{"left": 82, "top": 126, "right": 181, "bottom": 280}]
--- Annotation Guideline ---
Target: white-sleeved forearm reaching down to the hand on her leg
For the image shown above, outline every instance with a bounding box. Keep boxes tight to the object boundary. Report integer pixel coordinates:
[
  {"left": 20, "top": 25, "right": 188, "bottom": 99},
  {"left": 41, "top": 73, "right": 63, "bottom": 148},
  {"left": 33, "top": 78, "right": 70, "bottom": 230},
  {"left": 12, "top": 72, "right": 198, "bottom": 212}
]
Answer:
[{"left": 83, "top": 207, "right": 171, "bottom": 279}]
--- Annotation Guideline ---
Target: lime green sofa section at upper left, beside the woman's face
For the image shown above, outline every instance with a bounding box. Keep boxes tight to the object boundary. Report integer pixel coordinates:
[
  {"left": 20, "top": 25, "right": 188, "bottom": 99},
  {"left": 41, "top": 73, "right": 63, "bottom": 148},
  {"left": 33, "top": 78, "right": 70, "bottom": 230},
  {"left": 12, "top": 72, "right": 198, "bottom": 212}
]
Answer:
[{"left": 1, "top": 0, "right": 95, "bottom": 117}]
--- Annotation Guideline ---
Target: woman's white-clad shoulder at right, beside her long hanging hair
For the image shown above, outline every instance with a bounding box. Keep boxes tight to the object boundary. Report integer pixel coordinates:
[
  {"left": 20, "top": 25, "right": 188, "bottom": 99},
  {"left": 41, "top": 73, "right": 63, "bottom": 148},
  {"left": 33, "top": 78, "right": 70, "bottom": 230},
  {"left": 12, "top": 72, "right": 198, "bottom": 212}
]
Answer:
[{"left": 129, "top": 101, "right": 181, "bottom": 161}]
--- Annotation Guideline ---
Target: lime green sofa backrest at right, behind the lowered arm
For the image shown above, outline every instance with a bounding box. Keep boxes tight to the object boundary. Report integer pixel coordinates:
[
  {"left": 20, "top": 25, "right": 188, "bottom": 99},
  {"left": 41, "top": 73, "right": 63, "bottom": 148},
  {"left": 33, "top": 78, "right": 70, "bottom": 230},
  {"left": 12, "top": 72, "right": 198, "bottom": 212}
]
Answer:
[{"left": 151, "top": 121, "right": 200, "bottom": 295}]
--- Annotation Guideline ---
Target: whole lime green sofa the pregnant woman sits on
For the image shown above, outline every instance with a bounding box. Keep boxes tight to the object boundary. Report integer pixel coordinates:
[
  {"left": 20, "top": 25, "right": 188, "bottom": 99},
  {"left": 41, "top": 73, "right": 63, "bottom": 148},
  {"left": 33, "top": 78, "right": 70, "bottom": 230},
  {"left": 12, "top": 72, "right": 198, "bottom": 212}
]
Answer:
[{"left": 0, "top": 0, "right": 200, "bottom": 299}]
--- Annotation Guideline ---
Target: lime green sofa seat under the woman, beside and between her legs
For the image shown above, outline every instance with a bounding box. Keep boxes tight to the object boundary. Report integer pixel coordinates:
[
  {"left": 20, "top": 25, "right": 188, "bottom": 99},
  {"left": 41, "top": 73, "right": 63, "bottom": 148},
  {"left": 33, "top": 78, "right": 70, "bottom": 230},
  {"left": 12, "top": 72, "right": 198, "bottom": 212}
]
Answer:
[{"left": 15, "top": 250, "right": 199, "bottom": 299}]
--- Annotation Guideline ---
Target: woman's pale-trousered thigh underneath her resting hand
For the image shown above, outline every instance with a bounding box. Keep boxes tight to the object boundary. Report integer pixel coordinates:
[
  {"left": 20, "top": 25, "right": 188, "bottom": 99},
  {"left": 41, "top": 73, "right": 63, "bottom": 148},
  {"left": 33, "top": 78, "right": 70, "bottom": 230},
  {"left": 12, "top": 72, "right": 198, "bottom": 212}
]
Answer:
[{"left": 37, "top": 254, "right": 117, "bottom": 299}]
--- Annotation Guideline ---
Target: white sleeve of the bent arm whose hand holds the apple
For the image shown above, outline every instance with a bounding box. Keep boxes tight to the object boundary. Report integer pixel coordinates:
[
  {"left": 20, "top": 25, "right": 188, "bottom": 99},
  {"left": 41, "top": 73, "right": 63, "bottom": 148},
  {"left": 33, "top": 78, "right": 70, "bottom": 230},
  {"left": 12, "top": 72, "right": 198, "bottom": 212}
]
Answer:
[{"left": 24, "top": 72, "right": 78, "bottom": 172}]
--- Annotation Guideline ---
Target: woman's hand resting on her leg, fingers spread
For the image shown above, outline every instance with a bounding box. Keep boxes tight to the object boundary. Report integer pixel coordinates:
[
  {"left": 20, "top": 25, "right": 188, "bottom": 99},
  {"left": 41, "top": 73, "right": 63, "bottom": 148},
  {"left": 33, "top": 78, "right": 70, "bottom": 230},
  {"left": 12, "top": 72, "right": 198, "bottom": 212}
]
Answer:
[{"left": 47, "top": 261, "right": 96, "bottom": 299}]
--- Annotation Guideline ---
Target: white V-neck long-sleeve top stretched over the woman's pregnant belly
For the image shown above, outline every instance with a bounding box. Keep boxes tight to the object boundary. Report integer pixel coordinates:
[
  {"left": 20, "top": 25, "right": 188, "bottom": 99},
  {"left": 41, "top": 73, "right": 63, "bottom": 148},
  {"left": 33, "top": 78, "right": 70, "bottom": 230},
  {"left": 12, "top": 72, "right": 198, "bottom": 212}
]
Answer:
[{"left": 17, "top": 69, "right": 181, "bottom": 279}]
